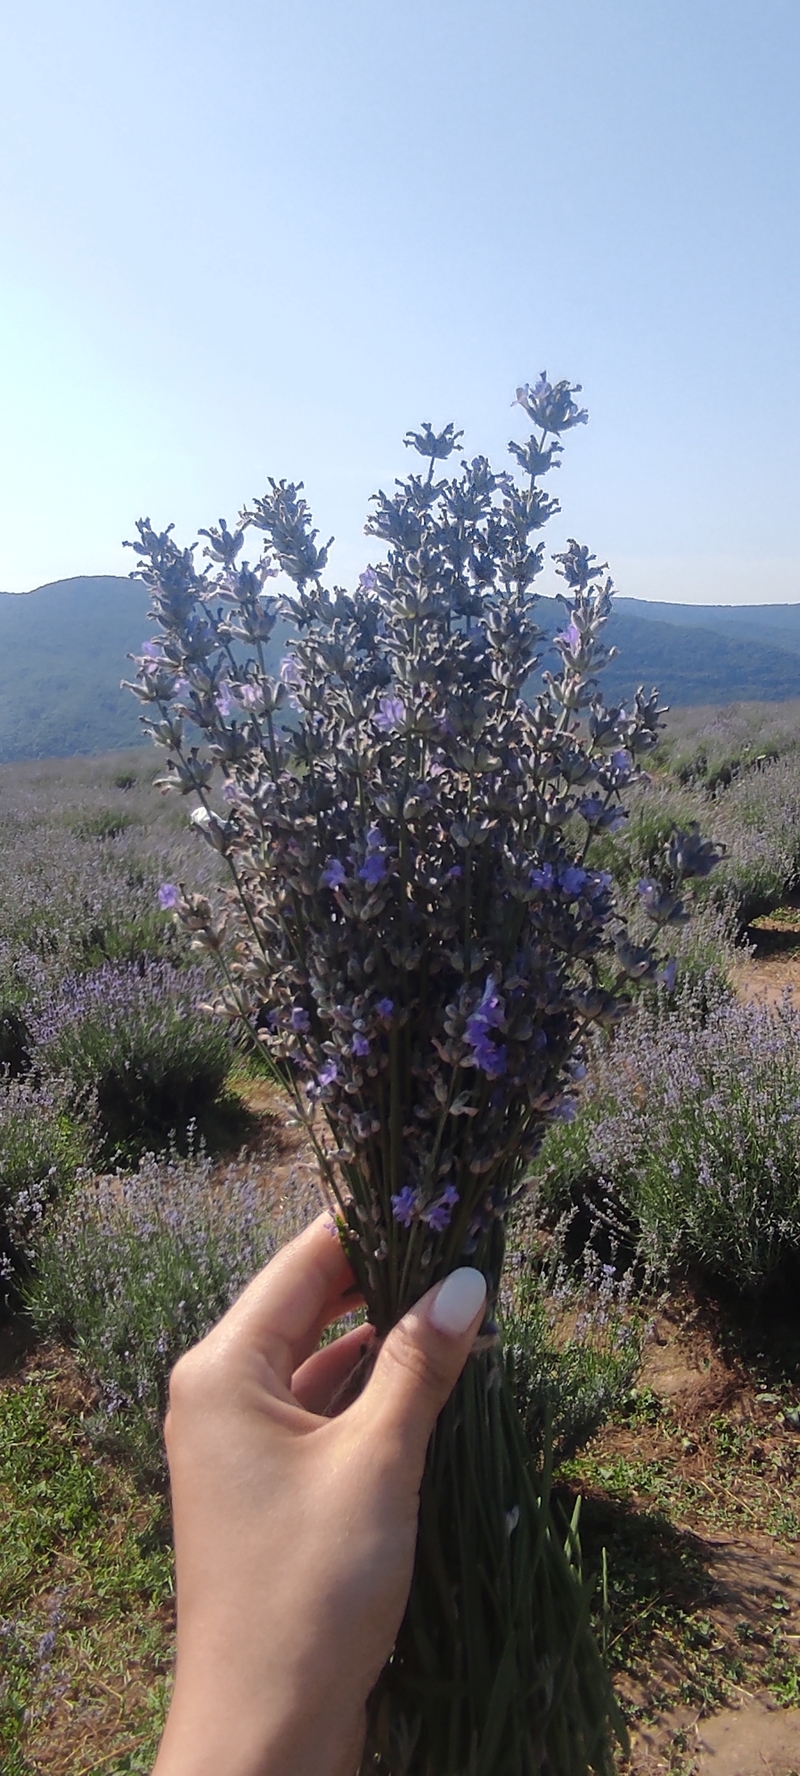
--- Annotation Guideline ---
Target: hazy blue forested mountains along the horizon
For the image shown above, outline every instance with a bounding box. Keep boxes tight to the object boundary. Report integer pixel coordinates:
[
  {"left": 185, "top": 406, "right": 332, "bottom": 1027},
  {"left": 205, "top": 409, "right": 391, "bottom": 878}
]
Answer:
[{"left": 0, "top": 575, "right": 800, "bottom": 762}]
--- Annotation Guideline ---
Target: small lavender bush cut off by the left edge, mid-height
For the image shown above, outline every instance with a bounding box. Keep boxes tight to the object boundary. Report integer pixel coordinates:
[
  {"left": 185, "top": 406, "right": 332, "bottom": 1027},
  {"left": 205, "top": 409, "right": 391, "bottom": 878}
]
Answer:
[{"left": 0, "top": 1080, "right": 92, "bottom": 1300}]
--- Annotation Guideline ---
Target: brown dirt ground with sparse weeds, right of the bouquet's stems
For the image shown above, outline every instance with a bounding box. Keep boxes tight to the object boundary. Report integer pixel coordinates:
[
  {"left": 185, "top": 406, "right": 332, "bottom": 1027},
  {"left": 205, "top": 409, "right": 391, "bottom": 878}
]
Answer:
[{"left": 600, "top": 1296, "right": 800, "bottom": 1776}]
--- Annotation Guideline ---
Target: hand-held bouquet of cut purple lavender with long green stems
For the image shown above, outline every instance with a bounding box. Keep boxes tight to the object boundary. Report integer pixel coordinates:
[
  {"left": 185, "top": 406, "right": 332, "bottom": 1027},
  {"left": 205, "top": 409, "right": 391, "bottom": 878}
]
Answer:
[{"left": 125, "top": 375, "right": 708, "bottom": 1776}]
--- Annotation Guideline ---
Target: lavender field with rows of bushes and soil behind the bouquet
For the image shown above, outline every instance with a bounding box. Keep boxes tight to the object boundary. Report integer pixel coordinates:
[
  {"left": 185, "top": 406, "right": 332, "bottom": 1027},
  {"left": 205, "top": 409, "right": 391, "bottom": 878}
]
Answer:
[{"left": 0, "top": 728, "right": 800, "bottom": 1776}]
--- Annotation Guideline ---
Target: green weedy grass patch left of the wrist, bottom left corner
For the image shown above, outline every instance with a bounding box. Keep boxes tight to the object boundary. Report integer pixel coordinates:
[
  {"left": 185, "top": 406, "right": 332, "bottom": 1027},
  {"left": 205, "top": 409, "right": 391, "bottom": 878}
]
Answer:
[{"left": 0, "top": 1352, "right": 172, "bottom": 1776}]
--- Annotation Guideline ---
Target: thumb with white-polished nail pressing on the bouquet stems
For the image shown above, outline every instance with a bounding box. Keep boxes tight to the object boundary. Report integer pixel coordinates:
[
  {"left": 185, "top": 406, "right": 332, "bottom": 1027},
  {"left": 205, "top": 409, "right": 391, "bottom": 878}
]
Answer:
[{"left": 356, "top": 1268, "right": 485, "bottom": 1478}]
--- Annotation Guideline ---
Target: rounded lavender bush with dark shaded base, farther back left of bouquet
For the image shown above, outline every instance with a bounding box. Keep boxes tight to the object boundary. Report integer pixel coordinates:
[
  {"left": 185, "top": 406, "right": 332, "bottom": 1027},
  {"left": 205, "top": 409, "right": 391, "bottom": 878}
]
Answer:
[{"left": 34, "top": 963, "right": 231, "bottom": 1156}]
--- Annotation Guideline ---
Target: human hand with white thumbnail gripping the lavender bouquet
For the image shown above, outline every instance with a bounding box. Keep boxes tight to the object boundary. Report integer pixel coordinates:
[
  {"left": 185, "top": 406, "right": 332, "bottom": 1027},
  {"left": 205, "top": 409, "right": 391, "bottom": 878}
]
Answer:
[{"left": 153, "top": 1215, "right": 485, "bottom": 1776}]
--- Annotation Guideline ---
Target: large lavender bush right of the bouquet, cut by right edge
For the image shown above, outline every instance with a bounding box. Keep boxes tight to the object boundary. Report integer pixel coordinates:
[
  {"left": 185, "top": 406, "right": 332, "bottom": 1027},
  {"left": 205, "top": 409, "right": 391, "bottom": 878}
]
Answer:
[{"left": 540, "top": 991, "right": 800, "bottom": 1291}]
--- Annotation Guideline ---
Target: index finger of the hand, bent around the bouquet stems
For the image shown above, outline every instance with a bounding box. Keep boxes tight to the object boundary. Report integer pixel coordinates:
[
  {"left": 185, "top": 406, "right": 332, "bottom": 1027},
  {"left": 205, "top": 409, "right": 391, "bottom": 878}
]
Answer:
[{"left": 214, "top": 1209, "right": 361, "bottom": 1387}]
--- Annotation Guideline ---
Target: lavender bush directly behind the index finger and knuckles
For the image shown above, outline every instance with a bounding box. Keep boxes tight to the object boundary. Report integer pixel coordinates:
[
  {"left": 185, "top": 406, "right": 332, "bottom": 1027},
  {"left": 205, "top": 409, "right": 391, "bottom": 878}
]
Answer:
[{"left": 28, "top": 1151, "right": 315, "bottom": 1469}]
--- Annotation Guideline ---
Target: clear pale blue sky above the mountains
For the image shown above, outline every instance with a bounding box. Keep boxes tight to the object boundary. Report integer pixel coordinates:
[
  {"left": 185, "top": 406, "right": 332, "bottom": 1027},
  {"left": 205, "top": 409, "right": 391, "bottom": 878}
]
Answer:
[{"left": 0, "top": 0, "right": 800, "bottom": 602}]
